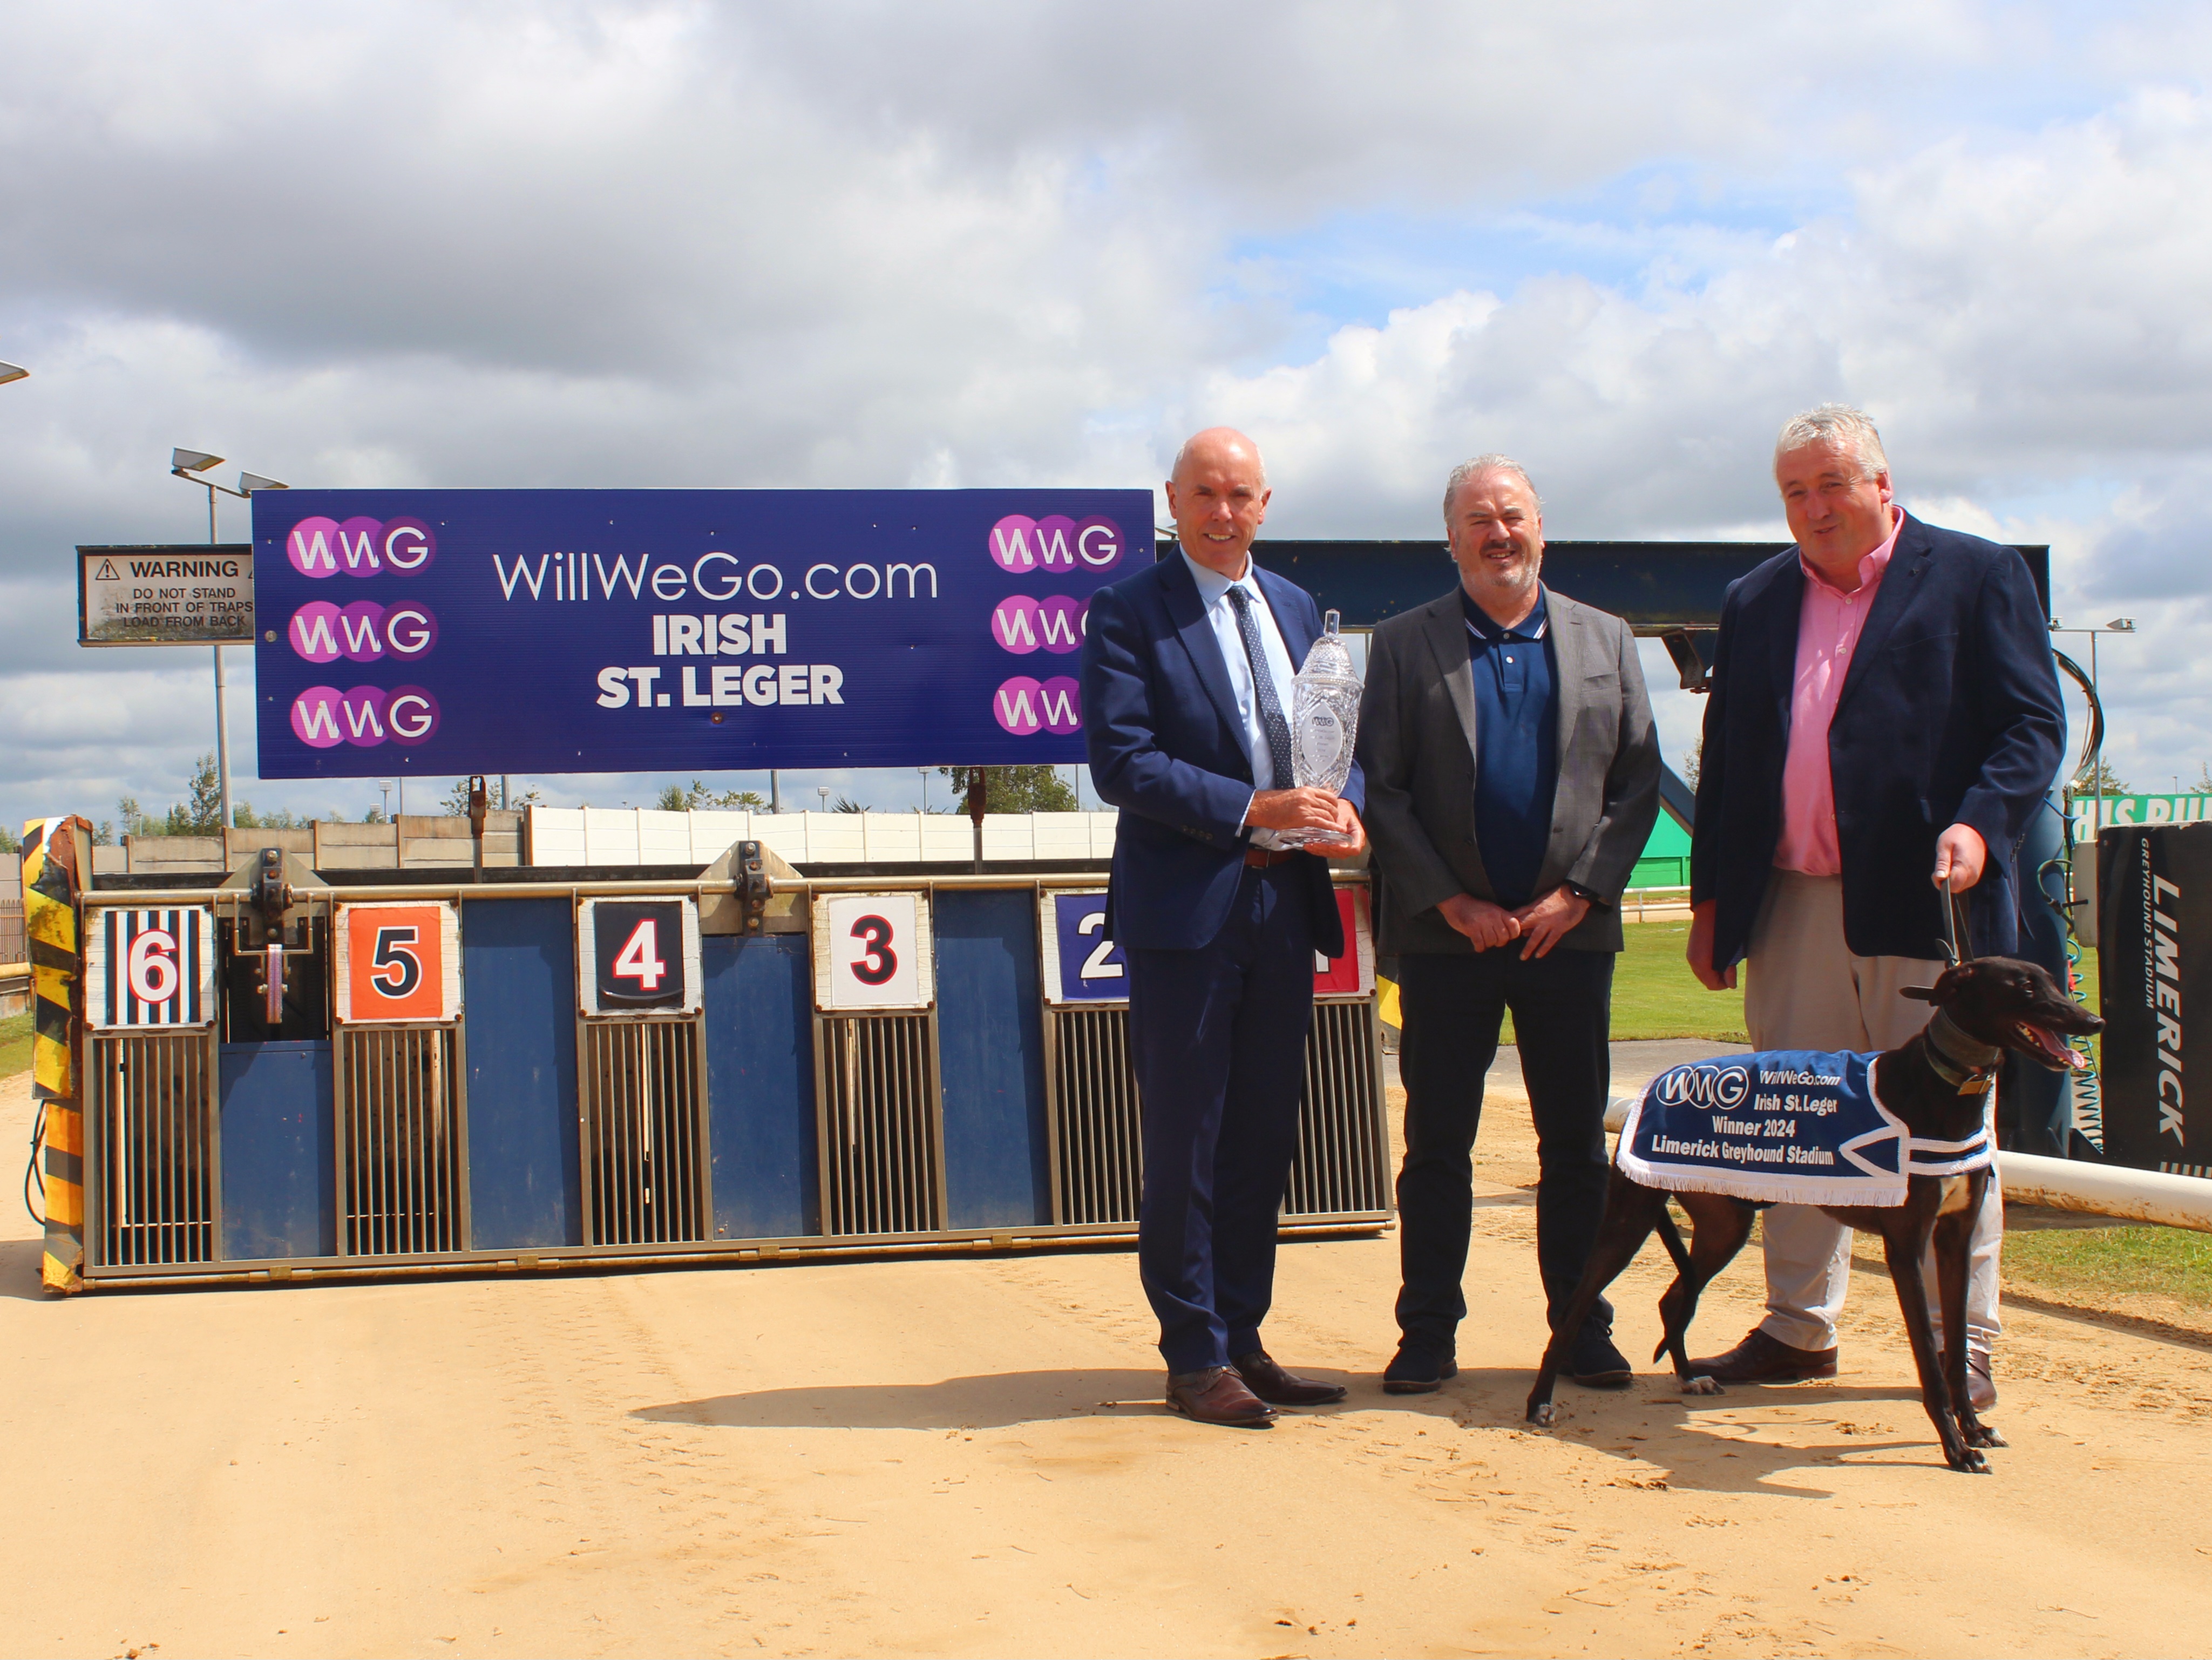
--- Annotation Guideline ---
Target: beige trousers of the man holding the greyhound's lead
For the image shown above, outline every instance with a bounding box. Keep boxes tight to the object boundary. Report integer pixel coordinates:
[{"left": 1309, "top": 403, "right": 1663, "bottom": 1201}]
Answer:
[{"left": 1743, "top": 870, "right": 2004, "bottom": 1352}]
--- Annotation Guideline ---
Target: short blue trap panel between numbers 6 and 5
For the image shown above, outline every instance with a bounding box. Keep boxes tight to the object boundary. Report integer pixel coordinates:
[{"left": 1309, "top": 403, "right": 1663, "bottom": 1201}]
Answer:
[{"left": 217, "top": 1042, "right": 338, "bottom": 1262}]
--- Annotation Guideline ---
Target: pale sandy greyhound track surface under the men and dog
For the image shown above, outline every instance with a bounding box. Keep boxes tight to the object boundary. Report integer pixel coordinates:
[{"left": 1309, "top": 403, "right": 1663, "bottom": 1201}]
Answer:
[{"left": 0, "top": 1078, "right": 2212, "bottom": 1660}]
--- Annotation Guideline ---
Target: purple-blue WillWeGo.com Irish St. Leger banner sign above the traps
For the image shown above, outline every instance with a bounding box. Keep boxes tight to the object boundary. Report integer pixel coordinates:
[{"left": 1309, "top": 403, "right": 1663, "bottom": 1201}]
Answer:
[{"left": 254, "top": 489, "right": 1152, "bottom": 779}]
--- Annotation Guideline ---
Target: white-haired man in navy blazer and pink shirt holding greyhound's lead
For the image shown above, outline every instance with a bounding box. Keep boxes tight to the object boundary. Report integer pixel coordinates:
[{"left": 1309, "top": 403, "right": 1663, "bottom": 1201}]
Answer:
[{"left": 1688, "top": 403, "right": 2066, "bottom": 1408}]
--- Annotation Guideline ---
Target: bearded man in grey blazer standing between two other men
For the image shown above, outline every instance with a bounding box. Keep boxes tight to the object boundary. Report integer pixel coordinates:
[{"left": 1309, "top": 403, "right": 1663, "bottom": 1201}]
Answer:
[{"left": 1358, "top": 456, "right": 1659, "bottom": 1394}]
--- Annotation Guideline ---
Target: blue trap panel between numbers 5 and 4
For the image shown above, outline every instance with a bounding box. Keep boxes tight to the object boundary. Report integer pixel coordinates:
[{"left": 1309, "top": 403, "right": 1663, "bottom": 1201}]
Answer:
[{"left": 460, "top": 899, "right": 584, "bottom": 1251}]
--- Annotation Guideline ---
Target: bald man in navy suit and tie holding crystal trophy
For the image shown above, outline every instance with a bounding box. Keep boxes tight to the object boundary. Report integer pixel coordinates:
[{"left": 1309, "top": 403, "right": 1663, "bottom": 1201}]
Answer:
[{"left": 1084, "top": 427, "right": 1367, "bottom": 1428}]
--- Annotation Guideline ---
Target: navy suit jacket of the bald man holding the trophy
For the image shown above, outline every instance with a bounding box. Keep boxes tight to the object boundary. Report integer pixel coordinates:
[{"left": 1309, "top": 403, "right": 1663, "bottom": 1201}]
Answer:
[{"left": 1084, "top": 553, "right": 1367, "bottom": 956}]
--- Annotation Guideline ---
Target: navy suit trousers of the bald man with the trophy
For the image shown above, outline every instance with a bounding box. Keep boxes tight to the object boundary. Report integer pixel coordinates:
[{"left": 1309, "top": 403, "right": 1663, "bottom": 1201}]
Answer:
[{"left": 1128, "top": 861, "right": 1314, "bottom": 1372}]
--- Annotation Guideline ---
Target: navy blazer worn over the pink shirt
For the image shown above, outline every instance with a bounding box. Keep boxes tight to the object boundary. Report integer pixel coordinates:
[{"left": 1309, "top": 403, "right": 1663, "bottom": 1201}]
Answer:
[{"left": 1690, "top": 513, "right": 2066, "bottom": 967}]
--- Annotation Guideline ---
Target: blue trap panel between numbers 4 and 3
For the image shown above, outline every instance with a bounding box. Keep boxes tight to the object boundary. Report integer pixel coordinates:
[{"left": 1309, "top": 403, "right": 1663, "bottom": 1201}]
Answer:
[{"left": 699, "top": 934, "right": 820, "bottom": 1239}]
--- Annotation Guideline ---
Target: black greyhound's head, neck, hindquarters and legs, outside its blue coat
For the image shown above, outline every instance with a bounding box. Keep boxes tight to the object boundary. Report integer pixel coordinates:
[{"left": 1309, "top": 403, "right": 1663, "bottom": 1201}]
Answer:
[{"left": 1529, "top": 956, "right": 2104, "bottom": 1474}]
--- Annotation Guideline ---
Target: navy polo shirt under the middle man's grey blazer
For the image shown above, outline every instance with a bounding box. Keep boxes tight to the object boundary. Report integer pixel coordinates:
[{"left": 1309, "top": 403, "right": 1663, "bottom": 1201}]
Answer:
[{"left": 1460, "top": 587, "right": 1559, "bottom": 910}]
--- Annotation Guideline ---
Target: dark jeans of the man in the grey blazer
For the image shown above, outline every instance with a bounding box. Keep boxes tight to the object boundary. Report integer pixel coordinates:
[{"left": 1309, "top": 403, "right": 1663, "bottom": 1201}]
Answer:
[{"left": 1398, "top": 945, "right": 1612, "bottom": 1354}]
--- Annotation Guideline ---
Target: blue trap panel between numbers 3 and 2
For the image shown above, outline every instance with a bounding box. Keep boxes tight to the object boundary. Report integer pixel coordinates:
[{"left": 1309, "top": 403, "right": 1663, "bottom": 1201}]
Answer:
[{"left": 931, "top": 890, "right": 1053, "bottom": 1229}]
